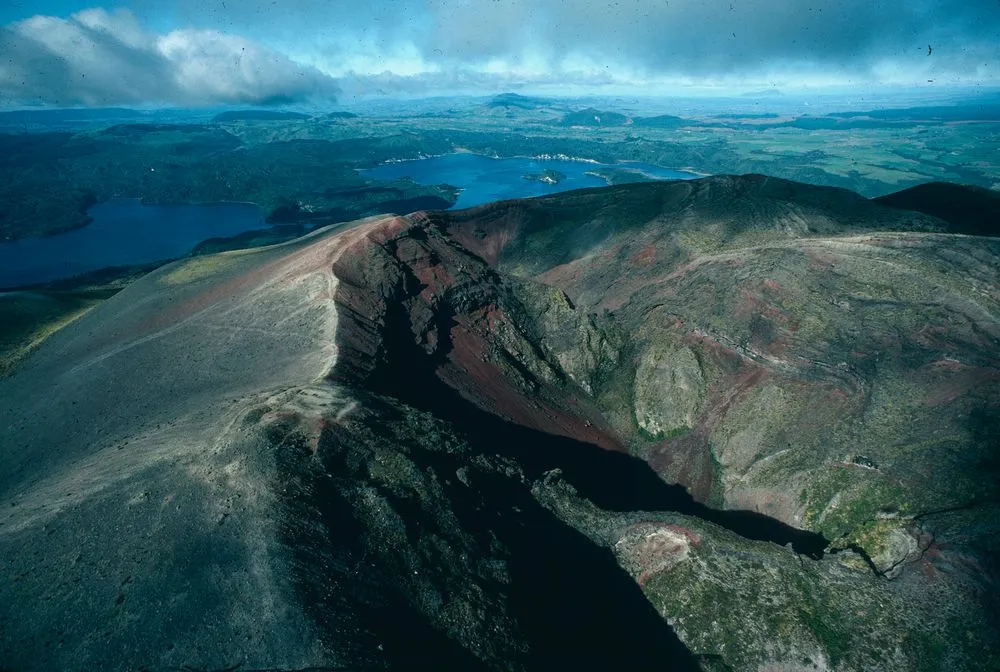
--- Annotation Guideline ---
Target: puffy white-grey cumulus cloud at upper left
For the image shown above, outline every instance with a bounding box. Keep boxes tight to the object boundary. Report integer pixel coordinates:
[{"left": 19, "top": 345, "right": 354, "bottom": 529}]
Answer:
[{"left": 0, "top": 9, "right": 339, "bottom": 106}]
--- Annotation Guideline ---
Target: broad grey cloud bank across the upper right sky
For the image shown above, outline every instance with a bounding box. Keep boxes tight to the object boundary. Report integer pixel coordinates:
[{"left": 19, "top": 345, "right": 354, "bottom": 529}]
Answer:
[{"left": 402, "top": 0, "right": 1000, "bottom": 85}]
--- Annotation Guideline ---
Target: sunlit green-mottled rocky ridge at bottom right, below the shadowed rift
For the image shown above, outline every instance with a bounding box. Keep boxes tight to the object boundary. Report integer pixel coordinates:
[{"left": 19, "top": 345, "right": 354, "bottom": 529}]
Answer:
[{"left": 533, "top": 473, "right": 983, "bottom": 670}]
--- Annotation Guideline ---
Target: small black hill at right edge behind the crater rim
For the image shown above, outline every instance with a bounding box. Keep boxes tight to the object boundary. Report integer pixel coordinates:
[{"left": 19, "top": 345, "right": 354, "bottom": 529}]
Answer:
[{"left": 874, "top": 182, "right": 1000, "bottom": 236}]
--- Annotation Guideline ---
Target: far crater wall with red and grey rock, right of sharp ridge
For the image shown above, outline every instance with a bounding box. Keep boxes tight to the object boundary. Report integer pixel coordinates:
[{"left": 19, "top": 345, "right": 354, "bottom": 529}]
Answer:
[{"left": 335, "top": 176, "right": 1000, "bottom": 562}]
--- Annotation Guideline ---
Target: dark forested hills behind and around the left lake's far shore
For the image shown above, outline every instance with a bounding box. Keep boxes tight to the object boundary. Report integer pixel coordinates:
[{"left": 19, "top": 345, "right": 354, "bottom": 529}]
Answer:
[{"left": 0, "top": 124, "right": 457, "bottom": 240}]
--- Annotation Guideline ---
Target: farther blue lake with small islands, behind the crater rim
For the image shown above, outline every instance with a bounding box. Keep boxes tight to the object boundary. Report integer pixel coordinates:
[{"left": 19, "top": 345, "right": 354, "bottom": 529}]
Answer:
[{"left": 360, "top": 153, "right": 700, "bottom": 208}]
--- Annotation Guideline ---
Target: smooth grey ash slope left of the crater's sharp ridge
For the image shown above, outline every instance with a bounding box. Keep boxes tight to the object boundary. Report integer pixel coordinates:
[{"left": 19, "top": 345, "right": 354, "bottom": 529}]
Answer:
[{"left": 0, "top": 223, "right": 372, "bottom": 669}]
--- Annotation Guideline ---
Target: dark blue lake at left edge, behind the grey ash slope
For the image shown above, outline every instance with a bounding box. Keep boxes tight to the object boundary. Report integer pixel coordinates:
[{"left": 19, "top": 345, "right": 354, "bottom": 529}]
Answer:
[{"left": 0, "top": 199, "right": 268, "bottom": 287}]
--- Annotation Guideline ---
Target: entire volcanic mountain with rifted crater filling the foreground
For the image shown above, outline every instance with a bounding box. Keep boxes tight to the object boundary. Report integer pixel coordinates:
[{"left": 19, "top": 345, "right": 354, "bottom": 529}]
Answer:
[{"left": 0, "top": 176, "right": 1000, "bottom": 670}]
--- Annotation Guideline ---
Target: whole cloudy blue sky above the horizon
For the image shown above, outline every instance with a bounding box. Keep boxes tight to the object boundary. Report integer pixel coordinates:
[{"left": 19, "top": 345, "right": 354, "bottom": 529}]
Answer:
[{"left": 0, "top": 0, "right": 1000, "bottom": 106}]
